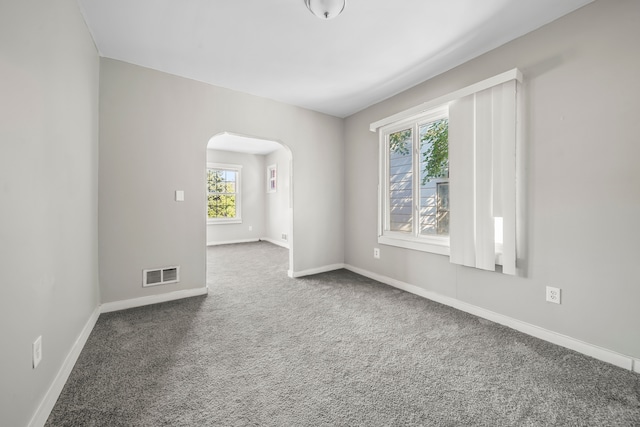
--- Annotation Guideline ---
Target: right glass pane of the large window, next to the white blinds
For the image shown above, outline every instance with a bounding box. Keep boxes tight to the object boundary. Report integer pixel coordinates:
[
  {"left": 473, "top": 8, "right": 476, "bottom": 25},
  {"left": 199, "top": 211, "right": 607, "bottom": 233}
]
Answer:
[{"left": 419, "top": 119, "right": 449, "bottom": 236}]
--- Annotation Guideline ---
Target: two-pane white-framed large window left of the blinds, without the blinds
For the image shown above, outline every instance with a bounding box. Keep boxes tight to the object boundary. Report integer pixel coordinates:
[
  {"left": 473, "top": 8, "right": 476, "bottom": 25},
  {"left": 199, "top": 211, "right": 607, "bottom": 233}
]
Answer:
[{"left": 381, "top": 107, "right": 449, "bottom": 254}]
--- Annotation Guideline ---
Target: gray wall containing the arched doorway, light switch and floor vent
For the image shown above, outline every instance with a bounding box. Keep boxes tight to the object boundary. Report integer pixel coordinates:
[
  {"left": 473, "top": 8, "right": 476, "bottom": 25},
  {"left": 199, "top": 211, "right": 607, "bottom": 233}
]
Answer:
[{"left": 99, "top": 59, "right": 344, "bottom": 302}]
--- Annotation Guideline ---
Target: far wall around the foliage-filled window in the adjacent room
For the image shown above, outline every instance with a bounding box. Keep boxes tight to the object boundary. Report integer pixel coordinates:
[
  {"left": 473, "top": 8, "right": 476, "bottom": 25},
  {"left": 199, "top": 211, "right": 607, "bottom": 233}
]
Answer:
[{"left": 207, "top": 150, "right": 267, "bottom": 244}]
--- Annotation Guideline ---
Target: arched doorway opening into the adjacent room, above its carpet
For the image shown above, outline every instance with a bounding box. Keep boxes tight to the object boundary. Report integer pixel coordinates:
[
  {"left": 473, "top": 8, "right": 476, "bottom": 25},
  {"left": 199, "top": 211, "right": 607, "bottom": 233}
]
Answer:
[{"left": 206, "top": 132, "right": 293, "bottom": 271}]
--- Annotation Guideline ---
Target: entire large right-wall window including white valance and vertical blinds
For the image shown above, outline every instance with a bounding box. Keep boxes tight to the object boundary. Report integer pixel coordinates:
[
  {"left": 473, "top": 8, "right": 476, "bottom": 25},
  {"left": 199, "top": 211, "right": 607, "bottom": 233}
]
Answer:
[{"left": 370, "top": 69, "right": 522, "bottom": 274}]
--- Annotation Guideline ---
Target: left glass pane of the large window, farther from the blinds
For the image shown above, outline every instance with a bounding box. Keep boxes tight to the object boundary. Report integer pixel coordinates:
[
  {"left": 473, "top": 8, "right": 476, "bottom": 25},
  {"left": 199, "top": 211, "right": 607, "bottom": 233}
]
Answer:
[{"left": 389, "top": 129, "right": 413, "bottom": 232}]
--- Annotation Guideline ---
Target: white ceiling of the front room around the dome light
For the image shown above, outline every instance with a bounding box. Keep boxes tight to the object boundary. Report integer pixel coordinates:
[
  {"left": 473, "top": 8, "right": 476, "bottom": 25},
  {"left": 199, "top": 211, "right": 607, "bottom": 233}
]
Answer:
[{"left": 78, "top": 0, "right": 593, "bottom": 117}]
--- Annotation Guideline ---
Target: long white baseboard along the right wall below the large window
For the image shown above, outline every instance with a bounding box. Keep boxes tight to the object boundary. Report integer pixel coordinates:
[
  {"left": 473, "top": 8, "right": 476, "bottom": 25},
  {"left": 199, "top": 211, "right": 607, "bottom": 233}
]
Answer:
[{"left": 344, "top": 264, "right": 640, "bottom": 372}]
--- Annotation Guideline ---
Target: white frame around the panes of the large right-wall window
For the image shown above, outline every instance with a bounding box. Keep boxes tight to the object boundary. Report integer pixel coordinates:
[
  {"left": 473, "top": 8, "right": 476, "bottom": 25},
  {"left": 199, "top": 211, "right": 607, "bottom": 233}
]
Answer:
[{"left": 378, "top": 104, "right": 450, "bottom": 255}]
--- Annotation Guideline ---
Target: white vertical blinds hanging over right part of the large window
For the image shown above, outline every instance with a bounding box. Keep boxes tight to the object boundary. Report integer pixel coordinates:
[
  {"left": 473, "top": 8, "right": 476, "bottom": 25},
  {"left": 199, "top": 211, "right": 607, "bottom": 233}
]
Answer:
[{"left": 449, "top": 80, "right": 517, "bottom": 275}]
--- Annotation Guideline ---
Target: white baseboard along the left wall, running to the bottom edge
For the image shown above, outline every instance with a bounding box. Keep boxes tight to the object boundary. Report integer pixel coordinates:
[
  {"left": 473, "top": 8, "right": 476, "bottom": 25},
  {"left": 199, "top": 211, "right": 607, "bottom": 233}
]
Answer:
[{"left": 29, "top": 307, "right": 100, "bottom": 427}]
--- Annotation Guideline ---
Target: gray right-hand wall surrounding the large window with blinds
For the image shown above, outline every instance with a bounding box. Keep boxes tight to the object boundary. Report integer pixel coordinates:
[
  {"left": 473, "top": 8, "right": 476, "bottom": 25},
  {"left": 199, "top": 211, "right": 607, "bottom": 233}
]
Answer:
[{"left": 345, "top": 0, "right": 640, "bottom": 358}]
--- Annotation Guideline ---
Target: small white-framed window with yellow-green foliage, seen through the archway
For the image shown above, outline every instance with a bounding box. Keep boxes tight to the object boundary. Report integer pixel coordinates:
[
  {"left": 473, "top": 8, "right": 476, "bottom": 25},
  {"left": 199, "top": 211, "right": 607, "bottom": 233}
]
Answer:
[{"left": 207, "top": 163, "right": 242, "bottom": 223}]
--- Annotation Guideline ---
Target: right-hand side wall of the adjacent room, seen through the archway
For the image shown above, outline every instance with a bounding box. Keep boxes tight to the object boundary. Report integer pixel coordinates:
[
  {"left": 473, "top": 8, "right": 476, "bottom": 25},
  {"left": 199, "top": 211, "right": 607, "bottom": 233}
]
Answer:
[{"left": 264, "top": 148, "right": 290, "bottom": 246}]
